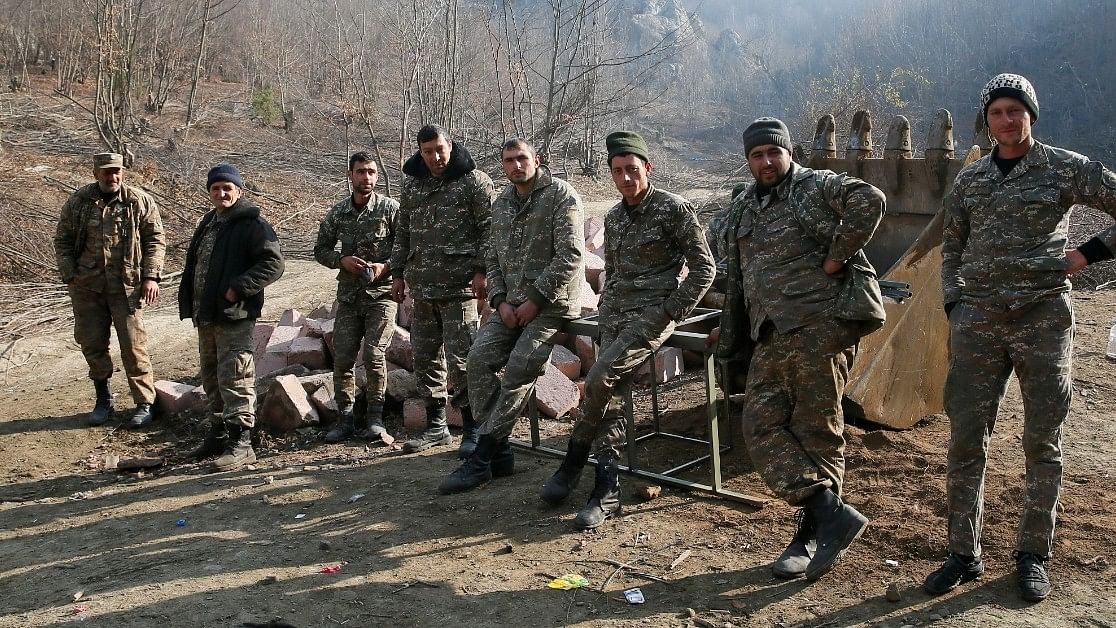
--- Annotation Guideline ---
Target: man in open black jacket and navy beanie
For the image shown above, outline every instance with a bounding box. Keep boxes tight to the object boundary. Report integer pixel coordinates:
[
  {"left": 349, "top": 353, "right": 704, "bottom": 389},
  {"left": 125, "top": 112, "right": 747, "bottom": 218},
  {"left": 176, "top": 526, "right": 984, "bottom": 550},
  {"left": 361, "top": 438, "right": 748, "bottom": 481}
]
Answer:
[{"left": 179, "top": 164, "right": 283, "bottom": 471}]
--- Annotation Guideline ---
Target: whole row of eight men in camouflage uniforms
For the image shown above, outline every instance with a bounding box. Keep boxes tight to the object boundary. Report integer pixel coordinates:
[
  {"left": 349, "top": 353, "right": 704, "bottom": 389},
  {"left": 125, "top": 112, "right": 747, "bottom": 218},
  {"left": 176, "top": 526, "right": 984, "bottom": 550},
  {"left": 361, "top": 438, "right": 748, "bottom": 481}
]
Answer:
[{"left": 55, "top": 74, "right": 1116, "bottom": 601}]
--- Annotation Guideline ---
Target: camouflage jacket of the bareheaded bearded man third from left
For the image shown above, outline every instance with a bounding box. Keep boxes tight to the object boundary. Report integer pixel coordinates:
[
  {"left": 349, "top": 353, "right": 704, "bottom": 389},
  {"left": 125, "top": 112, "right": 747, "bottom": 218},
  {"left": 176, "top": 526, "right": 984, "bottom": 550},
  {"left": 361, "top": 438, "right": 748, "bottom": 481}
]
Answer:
[{"left": 314, "top": 193, "right": 400, "bottom": 303}]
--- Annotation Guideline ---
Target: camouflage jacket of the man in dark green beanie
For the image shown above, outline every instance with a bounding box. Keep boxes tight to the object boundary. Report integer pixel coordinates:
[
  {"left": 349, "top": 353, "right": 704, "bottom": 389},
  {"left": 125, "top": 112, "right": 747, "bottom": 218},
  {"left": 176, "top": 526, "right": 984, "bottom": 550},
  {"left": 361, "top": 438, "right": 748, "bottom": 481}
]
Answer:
[{"left": 600, "top": 185, "right": 715, "bottom": 321}]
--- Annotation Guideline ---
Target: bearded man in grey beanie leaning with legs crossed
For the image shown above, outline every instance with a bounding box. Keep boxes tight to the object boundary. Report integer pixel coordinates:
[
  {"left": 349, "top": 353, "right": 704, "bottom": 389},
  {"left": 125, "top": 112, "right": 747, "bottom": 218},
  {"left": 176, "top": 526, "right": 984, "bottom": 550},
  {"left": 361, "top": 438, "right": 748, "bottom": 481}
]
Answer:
[{"left": 712, "top": 118, "right": 884, "bottom": 580}]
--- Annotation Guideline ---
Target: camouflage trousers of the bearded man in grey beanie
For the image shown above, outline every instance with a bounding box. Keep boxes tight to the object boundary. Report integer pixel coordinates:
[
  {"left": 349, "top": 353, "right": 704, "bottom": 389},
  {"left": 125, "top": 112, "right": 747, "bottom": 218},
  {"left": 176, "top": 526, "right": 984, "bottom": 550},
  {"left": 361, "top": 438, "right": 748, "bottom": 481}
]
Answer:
[{"left": 743, "top": 319, "right": 859, "bottom": 505}]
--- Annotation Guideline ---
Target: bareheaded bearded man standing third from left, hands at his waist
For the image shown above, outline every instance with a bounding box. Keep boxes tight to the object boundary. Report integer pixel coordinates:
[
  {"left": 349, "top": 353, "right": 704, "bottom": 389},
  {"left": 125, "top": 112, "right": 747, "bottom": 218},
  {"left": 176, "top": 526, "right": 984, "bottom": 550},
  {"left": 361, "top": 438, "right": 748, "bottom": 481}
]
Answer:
[{"left": 314, "top": 153, "right": 400, "bottom": 443}]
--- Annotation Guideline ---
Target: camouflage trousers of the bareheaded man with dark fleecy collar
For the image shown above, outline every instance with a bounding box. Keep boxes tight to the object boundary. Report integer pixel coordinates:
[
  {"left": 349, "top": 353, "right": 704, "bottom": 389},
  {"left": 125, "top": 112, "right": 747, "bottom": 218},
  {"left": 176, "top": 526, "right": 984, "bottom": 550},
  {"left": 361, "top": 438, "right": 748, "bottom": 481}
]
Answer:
[{"left": 411, "top": 299, "right": 480, "bottom": 408}]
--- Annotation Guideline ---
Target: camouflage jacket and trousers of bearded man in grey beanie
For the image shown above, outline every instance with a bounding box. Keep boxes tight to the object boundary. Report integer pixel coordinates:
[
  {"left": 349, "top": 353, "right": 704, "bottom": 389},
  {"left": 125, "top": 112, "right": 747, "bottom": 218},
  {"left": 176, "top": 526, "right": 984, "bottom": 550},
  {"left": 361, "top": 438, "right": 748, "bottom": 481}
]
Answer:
[{"left": 718, "top": 164, "right": 884, "bottom": 505}]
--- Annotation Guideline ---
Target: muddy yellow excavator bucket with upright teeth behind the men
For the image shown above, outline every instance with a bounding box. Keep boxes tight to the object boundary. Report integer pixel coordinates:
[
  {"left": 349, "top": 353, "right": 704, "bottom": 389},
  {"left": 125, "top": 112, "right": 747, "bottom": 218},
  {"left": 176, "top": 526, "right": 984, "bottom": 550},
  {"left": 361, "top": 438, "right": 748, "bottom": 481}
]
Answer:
[{"left": 808, "top": 109, "right": 990, "bottom": 429}]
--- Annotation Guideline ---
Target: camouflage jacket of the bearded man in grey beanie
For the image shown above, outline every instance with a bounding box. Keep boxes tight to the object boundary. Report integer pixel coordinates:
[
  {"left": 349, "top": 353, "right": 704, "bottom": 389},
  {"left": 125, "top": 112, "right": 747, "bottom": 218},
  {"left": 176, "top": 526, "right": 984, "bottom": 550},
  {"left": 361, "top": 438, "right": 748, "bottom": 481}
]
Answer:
[{"left": 721, "top": 164, "right": 884, "bottom": 348}]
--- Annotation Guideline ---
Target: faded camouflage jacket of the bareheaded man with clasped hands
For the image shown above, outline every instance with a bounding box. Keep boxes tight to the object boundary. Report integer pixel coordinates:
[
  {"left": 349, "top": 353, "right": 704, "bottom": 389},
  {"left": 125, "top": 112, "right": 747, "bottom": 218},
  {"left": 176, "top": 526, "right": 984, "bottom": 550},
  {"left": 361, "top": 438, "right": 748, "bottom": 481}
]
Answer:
[{"left": 487, "top": 166, "right": 585, "bottom": 318}]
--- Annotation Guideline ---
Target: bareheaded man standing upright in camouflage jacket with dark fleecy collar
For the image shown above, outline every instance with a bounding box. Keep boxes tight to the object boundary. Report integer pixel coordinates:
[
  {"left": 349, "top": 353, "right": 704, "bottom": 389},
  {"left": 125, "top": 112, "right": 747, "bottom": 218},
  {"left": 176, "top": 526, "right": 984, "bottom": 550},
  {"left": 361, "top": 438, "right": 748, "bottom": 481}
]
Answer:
[{"left": 391, "top": 125, "right": 496, "bottom": 457}]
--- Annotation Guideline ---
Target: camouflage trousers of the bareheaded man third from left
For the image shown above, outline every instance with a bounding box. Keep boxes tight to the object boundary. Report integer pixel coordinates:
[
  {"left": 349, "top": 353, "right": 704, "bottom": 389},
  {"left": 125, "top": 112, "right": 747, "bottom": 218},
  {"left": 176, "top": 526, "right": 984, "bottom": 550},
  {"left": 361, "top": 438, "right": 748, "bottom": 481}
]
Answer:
[{"left": 334, "top": 293, "right": 397, "bottom": 408}]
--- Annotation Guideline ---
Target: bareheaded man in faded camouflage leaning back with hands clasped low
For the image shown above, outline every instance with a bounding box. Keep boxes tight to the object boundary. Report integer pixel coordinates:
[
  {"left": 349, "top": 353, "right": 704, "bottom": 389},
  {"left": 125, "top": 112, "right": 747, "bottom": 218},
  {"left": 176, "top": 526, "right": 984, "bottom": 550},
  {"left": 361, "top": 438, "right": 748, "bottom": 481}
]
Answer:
[{"left": 439, "top": 139, "right": 584, "bottom": 493}]
